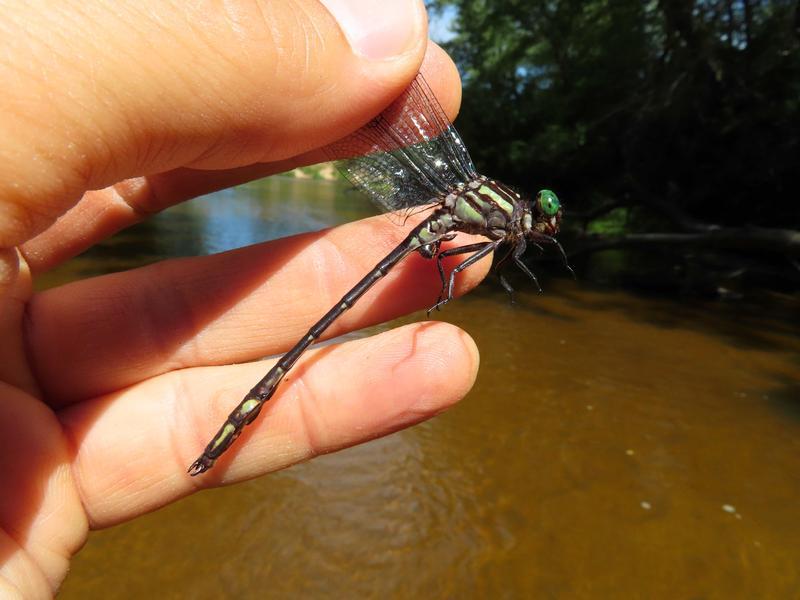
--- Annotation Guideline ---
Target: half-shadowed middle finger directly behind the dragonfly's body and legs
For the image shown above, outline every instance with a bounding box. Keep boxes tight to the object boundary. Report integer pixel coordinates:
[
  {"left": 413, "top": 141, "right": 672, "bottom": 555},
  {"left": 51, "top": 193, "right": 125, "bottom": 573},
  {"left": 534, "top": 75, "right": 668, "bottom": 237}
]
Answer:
[{"left": 26, "top": 216, "right": 490, "bottom": 406}]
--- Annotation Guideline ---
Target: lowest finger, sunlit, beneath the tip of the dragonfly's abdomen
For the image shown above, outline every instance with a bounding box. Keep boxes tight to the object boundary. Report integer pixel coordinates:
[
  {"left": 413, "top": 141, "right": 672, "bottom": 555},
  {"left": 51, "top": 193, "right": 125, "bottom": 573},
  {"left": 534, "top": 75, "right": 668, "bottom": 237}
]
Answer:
[{"left": 60, "top": 323, "right": 478, "bottom": 528}]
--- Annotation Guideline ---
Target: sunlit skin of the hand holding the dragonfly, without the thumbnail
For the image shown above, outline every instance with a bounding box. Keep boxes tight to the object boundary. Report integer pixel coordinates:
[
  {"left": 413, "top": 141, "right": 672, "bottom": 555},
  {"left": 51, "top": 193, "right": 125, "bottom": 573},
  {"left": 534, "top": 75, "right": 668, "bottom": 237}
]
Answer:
[{"left": 0, "top": 0, "right": 488, "bottom": 598}]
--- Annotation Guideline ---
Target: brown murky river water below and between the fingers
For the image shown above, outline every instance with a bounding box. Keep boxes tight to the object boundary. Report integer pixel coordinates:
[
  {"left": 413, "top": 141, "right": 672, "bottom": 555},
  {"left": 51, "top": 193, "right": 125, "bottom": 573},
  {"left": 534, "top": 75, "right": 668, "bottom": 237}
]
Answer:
[{"left": 49, "top": 180, "right": 800, "bottom": 599}]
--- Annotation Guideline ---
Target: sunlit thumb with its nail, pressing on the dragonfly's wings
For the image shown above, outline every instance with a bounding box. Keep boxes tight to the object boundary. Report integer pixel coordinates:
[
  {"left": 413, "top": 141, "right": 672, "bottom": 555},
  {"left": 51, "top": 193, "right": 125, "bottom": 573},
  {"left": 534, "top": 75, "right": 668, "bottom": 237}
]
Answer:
[{"left": 0, "top": 0, "right": 426, "bottom": 247}]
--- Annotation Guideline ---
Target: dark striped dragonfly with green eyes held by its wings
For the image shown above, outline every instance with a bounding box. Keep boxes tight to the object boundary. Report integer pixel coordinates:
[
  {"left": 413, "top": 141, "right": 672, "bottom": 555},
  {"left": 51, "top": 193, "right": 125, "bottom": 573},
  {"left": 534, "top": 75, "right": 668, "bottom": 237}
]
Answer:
[{"left": 188, "top": 74, "right": 569, "bottom": 476}]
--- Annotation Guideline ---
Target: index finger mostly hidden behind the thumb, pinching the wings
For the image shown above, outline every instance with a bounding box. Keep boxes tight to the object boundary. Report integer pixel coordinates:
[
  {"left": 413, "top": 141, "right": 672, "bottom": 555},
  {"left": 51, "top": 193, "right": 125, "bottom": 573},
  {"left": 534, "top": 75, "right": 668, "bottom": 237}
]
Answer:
[{"left": 22, "top": 42, "right": 461, "bottom": 273}]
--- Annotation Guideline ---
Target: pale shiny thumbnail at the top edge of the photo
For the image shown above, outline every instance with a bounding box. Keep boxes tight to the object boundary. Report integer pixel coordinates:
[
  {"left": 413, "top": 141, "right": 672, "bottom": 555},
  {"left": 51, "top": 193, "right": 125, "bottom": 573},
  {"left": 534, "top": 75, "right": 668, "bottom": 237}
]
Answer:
[{"left": 320, "top": 0, "right": 424, "bottom": 60}]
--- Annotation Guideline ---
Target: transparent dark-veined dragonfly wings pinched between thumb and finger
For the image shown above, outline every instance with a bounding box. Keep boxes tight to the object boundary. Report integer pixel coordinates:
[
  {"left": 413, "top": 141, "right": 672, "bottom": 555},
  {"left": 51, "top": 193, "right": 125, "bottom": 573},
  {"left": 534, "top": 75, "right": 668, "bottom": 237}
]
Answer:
[{"left": 326, "top": 74, "right": 477, "bottom": 211}]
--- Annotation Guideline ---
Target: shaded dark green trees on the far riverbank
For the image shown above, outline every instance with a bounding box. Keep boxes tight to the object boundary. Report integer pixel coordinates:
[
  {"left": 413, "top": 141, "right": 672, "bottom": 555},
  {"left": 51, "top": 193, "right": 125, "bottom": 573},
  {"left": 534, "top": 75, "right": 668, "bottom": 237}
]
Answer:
[{"left": 429, "top": 0, "right": 800, "bottom": 227}]
